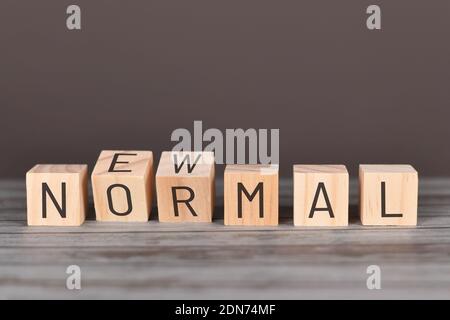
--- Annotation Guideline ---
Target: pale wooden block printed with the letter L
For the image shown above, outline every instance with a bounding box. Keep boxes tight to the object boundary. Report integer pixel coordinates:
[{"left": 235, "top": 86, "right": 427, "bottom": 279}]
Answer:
[{"left": 359, "top": 165, "right": 419, "bottom": 226}]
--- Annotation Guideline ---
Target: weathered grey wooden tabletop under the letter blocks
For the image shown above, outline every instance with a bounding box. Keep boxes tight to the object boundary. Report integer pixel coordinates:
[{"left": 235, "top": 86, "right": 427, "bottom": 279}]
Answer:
[{"left": 0, "top": 178, "right": 450, "bottom": 299}]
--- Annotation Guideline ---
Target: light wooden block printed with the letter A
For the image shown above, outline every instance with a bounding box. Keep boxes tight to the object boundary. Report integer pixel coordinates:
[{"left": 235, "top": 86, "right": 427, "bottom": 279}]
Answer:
[{"left": 294, "top": 165, "right": 349, "bottom": 226}]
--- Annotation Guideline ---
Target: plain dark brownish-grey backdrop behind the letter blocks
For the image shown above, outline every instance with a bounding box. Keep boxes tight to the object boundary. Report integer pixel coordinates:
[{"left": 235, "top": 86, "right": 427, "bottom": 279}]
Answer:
[{"left": 0, "top": 0, "right": 450, "bottom": 177}]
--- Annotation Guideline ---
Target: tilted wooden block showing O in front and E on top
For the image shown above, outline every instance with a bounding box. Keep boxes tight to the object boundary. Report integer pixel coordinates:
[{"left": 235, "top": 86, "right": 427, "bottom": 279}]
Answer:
[{"left": 92, "top": 150, "right": 153, "bottom": 222}]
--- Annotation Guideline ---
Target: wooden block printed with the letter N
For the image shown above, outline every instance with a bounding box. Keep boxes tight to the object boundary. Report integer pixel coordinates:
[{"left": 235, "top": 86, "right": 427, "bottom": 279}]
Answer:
[{"left": 26, "top": 164, "right": 87, "bottom": 226}]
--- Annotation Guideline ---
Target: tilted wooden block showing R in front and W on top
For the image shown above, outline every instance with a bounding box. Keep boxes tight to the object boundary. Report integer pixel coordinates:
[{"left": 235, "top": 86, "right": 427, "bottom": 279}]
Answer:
[{"left": 156, "top": 151, "right": 215, "bottom": 222}]
